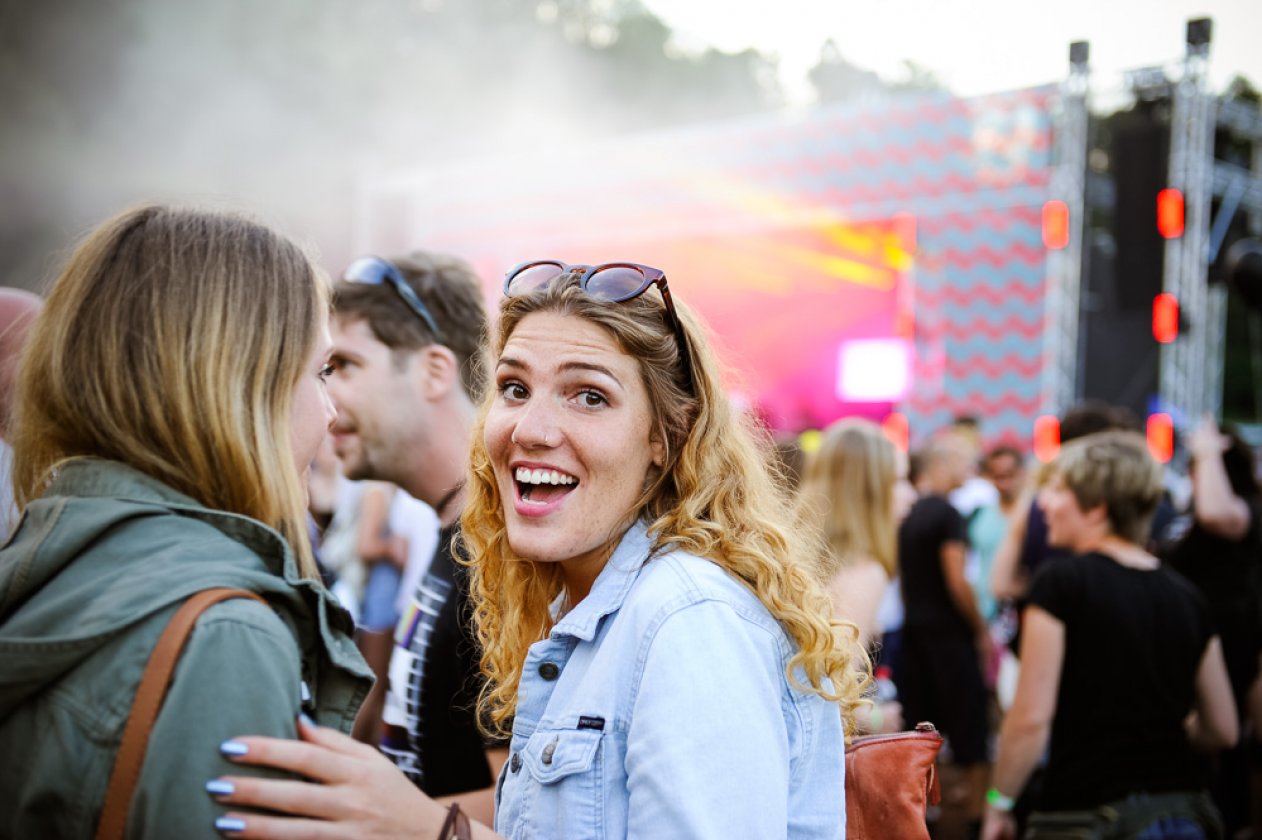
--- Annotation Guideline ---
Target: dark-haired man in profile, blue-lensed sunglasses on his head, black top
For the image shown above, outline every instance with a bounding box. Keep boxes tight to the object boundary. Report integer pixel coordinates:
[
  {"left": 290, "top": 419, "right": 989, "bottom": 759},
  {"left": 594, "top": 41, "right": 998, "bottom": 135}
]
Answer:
[{"left": 320, "top": 251, "right": 507, "bottom": 821}]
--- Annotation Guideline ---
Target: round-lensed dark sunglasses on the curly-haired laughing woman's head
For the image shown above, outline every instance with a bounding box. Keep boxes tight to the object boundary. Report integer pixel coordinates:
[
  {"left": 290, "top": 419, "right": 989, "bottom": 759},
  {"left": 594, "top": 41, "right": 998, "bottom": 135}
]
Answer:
[{"left": 504, "top": 260, "right": 693, "bottom": 391}]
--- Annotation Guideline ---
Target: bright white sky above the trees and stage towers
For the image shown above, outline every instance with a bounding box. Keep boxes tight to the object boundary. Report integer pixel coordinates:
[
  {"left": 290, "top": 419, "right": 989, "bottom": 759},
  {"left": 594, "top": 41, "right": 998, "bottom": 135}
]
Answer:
[{"left": 644, "top": 0, "right": 1262, "bottom": 101}]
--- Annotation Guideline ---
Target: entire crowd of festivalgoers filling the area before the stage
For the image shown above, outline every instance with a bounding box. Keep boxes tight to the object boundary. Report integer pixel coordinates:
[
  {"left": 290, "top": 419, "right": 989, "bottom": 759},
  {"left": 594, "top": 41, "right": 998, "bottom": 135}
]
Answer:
[{"left": 0, "top": 206, "right": 1262, "bottom": 840}]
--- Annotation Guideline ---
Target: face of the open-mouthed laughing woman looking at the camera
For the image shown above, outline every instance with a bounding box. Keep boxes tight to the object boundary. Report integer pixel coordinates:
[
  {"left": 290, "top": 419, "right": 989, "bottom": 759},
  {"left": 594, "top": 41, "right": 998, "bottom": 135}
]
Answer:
[{"left": 483, "top": 312, "right": 664, "bottom": 595}]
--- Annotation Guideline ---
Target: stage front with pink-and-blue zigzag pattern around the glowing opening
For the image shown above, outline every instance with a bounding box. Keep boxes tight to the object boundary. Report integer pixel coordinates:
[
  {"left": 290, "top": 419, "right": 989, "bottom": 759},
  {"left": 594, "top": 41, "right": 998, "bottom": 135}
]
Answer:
[{"left": 361, "top": 87, "right": 1055, "bottom": 445}]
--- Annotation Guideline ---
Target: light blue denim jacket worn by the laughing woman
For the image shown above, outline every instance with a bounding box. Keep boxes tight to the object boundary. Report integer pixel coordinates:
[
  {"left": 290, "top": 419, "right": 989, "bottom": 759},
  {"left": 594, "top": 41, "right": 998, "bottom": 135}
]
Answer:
[{"left": 495, "top": 523, "right": 846, "bottom": 840}]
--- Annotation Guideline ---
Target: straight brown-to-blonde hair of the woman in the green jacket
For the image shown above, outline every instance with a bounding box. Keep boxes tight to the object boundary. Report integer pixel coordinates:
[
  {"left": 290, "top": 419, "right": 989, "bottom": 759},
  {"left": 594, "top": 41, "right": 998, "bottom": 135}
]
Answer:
[{"left": 10, "top": 206, "right": 328, "bottom": 578}]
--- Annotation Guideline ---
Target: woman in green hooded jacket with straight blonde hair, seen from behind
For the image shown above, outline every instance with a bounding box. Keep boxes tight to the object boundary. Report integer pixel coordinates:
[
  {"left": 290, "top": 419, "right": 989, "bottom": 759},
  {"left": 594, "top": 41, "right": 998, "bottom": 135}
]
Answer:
[{"left": 0, "top": 206, "right": 369, "bottom": 837}]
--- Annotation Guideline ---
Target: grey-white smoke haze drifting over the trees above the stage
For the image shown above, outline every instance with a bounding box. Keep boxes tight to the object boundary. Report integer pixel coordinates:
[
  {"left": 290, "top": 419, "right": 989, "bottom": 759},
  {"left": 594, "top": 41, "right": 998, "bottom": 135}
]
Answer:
[{"left": 0, "top": 0, "right": 781, "bottom": 289}]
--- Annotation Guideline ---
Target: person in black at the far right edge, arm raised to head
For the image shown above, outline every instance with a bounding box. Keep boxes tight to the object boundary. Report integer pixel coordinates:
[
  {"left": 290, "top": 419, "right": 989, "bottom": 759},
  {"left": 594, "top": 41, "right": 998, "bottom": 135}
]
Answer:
[{"left": 1167, "top": 417, "right": 1262, "bottom": 831}]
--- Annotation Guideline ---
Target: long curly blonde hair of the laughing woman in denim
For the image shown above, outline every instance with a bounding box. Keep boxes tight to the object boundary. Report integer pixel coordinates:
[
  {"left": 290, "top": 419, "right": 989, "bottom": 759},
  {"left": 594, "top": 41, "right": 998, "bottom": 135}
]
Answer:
[{"left": 461, "top": 275, "right": 870, "bottom": 735}]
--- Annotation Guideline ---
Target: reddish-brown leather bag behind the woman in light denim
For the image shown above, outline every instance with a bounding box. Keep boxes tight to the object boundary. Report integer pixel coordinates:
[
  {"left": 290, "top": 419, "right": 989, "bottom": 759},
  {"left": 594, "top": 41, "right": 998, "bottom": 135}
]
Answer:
[{"left": 846, "top": 723, "right": 943, "bottom": 840}]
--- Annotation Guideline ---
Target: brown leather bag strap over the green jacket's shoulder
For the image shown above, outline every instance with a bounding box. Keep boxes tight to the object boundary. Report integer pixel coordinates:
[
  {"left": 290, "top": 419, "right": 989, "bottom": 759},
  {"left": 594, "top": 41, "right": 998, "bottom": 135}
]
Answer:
[{"left": 96, "top": 589, "right": 266, "bottom": 840}]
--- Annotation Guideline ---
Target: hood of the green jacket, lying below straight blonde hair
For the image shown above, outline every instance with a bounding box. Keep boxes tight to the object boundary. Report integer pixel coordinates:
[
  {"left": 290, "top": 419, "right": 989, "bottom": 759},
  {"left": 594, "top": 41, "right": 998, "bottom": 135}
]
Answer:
[{"left": 0, "top": 459, "right": 351, "bottom": 720}]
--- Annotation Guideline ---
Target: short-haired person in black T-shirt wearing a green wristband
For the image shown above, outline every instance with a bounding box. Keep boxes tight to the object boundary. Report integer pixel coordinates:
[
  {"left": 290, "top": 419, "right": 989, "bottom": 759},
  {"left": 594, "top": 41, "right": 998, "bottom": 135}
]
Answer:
[{"left": 982, "top": 431, "right": 1239, "bottom": 840}]
